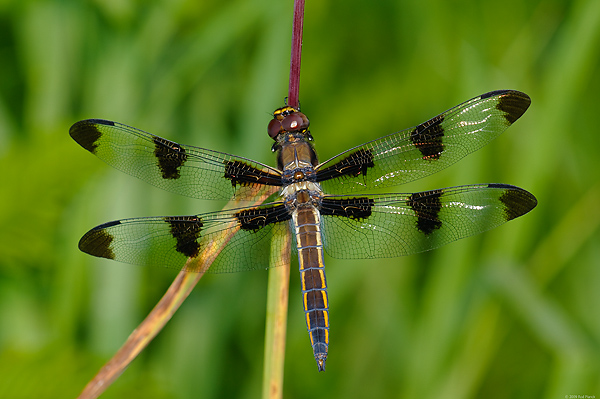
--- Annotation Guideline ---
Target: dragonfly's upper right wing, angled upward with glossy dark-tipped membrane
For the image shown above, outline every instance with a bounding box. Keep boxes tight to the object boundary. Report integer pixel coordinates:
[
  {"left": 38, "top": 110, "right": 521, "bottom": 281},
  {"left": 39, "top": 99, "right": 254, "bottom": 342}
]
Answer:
[{"left": 317, "top": 90, "right": 531, "bottom": 194}]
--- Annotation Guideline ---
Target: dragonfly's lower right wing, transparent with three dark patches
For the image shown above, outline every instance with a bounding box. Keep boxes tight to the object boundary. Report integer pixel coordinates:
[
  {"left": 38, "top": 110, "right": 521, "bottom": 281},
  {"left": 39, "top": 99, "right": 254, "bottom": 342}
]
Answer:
[{"left": 321, "top": 184, "right": 537, "bottom": 259}]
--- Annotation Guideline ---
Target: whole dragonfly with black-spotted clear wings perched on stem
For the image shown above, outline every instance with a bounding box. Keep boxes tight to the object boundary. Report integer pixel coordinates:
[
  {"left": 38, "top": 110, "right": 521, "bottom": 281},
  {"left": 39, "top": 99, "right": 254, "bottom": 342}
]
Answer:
[{"left": 69, "top": 90, "right": 537, "bottom": 371}]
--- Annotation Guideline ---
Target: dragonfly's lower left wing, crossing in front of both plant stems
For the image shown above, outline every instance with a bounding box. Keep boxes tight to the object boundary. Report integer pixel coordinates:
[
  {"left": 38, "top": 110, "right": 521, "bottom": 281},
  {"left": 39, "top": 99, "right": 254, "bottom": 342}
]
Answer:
[{"left": 79, "top": 203, "right": 289, "bottom": 273}]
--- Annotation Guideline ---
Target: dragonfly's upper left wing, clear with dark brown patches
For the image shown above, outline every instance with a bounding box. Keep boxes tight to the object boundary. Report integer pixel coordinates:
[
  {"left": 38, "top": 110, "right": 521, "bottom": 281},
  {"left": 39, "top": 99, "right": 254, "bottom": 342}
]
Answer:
[{"left": 69, "top": 119, "right": 281, "bottom": 200}]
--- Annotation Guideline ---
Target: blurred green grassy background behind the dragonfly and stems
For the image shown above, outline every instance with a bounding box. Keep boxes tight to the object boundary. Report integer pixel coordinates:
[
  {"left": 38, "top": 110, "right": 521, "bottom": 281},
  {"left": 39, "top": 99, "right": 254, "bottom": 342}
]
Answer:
[{"left": 0, "top": 0, "right": 600, "bottom": 399}]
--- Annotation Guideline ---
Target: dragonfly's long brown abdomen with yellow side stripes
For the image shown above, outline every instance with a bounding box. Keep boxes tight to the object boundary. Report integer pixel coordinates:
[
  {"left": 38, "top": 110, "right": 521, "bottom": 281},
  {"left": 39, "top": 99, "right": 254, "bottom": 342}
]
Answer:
[{"left": 292, "top": 206, "right": 329, "bottom": 371}]
